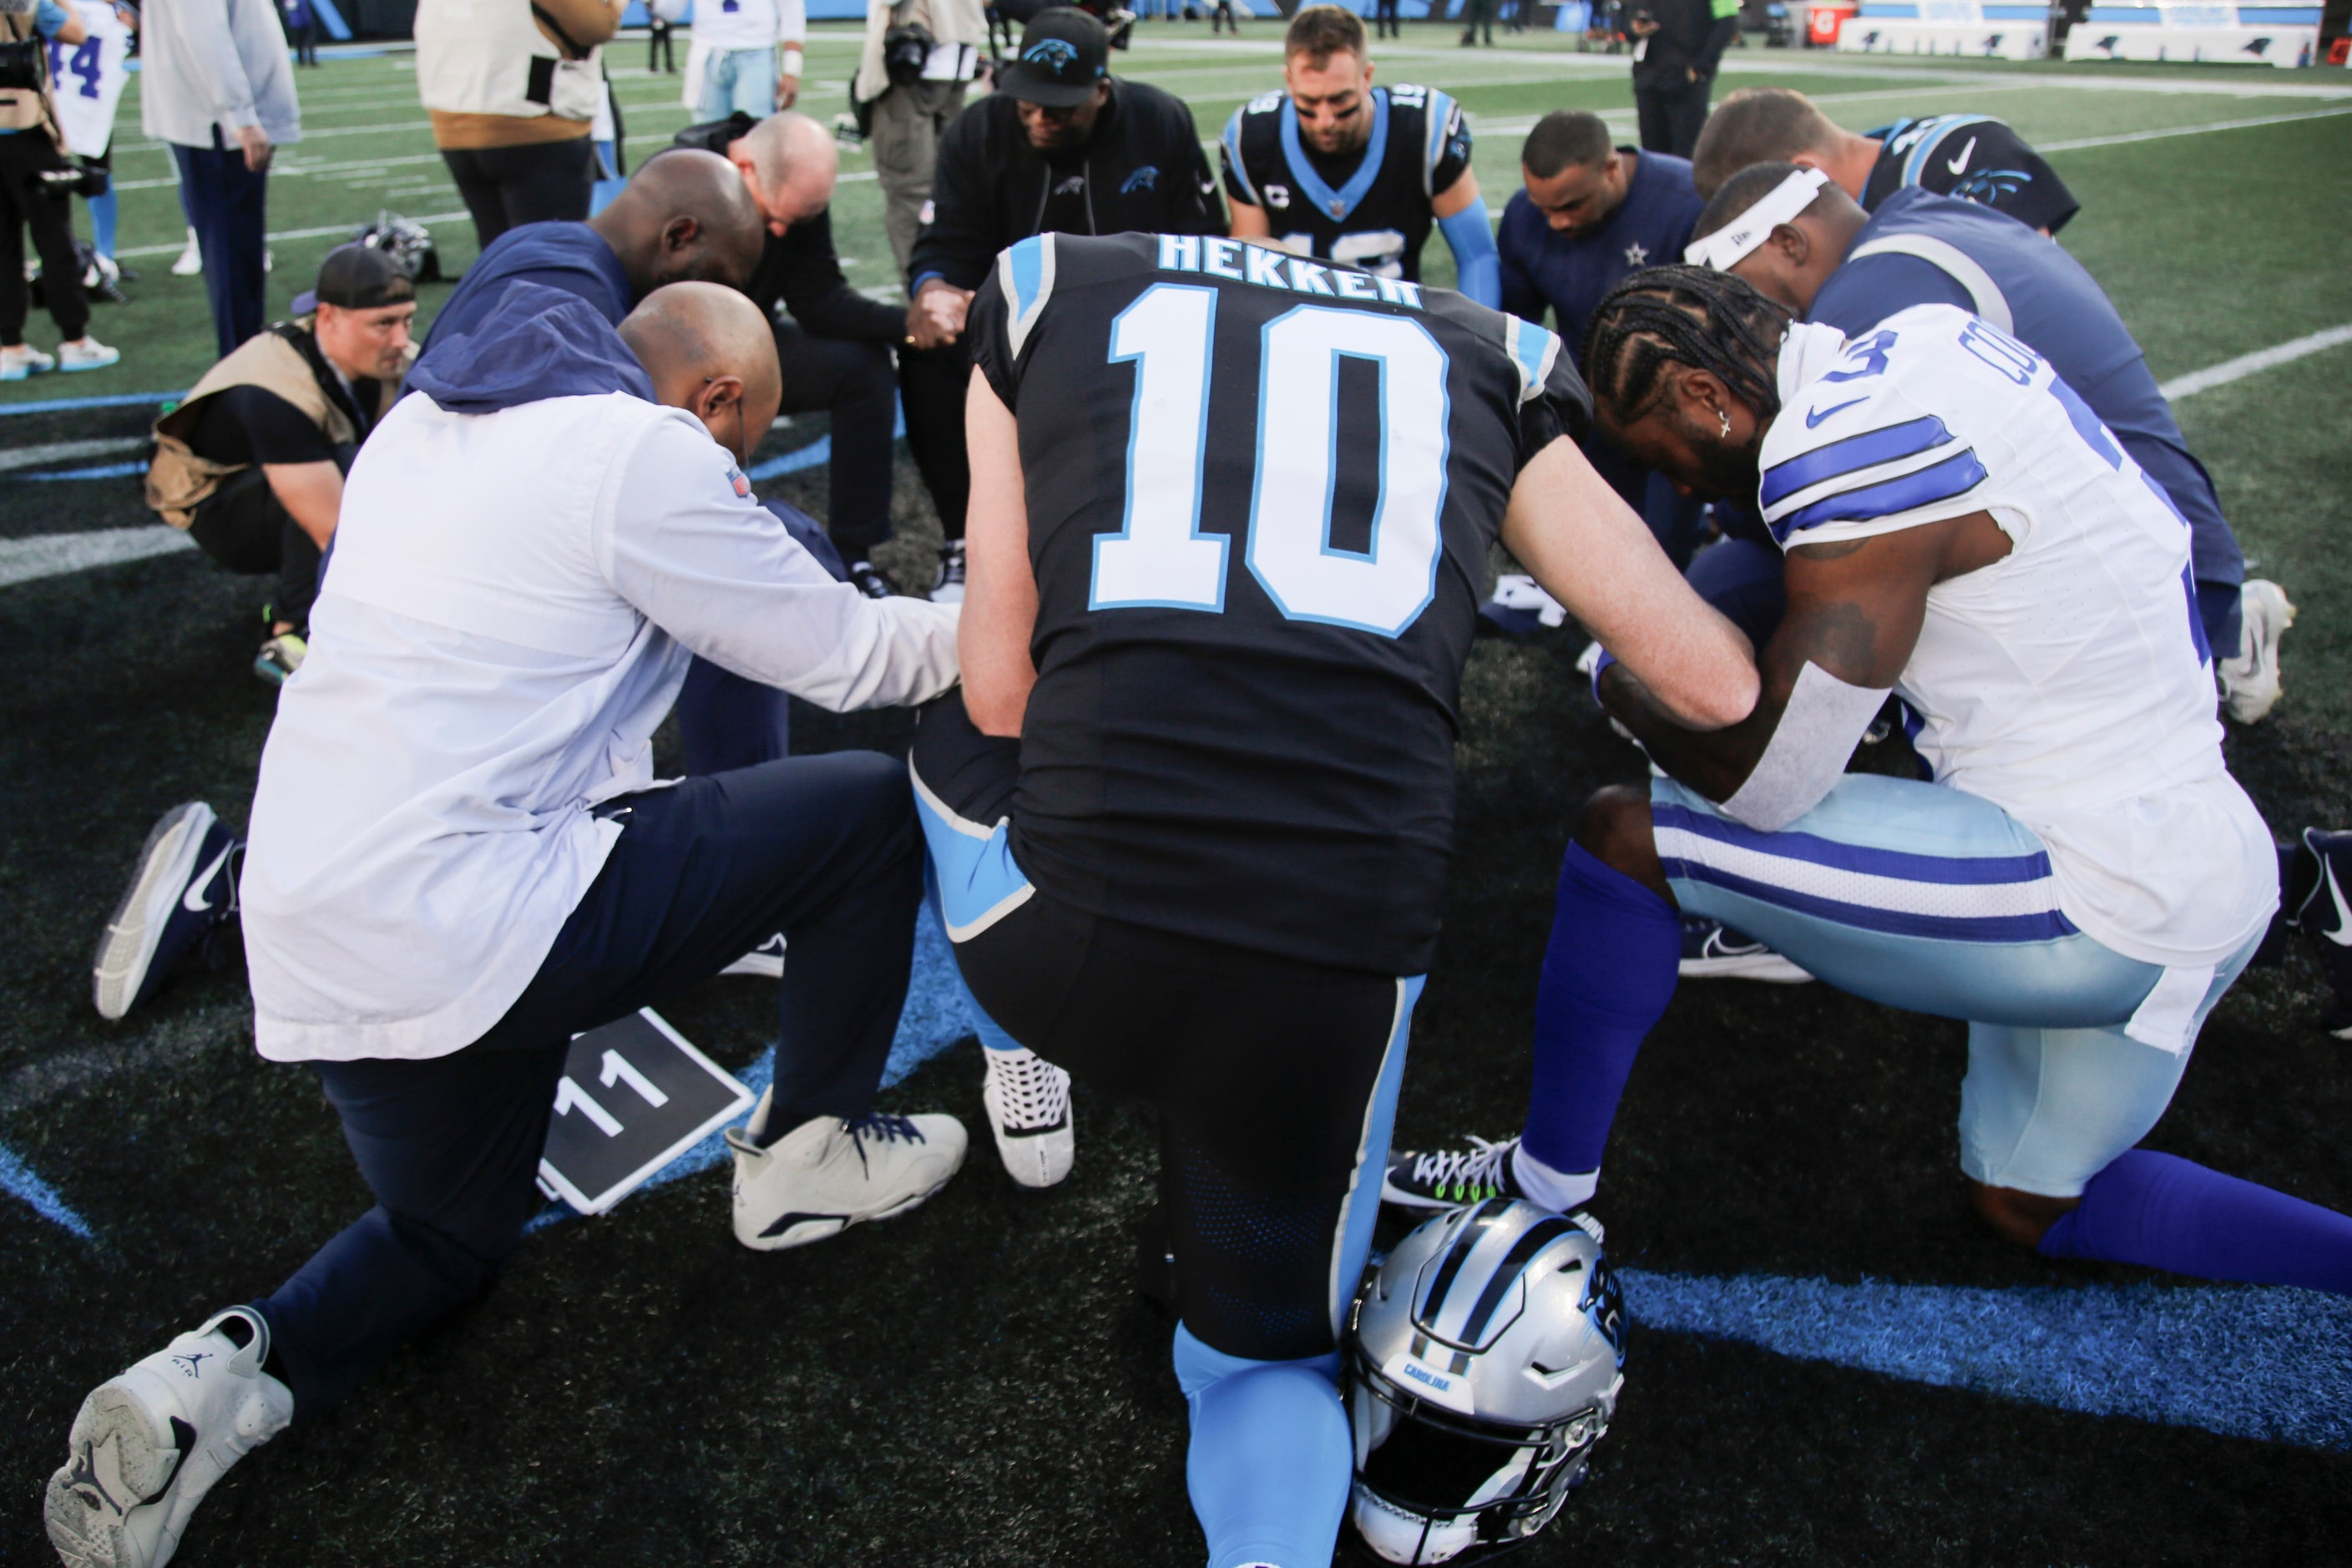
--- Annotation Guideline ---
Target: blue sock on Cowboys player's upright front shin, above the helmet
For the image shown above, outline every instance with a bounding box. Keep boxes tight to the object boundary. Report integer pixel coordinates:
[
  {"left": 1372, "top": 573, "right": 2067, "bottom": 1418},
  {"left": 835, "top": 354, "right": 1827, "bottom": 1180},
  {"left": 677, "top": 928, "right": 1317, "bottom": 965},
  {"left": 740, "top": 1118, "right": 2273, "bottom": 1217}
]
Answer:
[{"left": 1522, "top": 844, "right": 1682, "bottom": 1173}]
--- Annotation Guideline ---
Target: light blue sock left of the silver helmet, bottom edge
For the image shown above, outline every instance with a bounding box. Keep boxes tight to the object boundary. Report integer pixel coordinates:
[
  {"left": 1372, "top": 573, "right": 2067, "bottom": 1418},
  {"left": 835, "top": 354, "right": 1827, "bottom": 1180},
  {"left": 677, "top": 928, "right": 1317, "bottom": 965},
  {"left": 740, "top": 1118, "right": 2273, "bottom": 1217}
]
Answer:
[{"left": 1176, "top": 1323, "right": 1355, "bottom": 1568}]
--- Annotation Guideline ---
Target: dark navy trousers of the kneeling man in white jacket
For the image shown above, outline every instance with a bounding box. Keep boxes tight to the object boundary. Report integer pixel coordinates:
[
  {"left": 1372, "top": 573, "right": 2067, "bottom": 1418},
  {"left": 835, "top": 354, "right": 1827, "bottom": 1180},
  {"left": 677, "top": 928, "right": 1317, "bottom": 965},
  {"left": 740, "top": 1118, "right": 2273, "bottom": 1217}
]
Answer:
[{"left": 256, "top": 752, "right": 922, "bottom": 1420}]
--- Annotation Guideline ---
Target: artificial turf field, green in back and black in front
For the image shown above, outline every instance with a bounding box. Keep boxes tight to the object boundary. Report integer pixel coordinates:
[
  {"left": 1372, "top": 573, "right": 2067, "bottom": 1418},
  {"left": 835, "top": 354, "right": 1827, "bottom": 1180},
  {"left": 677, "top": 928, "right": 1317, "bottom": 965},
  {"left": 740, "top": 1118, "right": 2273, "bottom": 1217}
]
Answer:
[{"left": 0, "top": 23, "right": 2352, "bottom": 1568}]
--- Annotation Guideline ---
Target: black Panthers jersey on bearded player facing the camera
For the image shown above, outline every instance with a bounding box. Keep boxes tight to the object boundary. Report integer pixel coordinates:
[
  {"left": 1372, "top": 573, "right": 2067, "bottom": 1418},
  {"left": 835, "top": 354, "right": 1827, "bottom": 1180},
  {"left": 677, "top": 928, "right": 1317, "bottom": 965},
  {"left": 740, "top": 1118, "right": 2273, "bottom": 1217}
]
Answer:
[{"left": 1218, "top": 84, "right": 1470, "bottom": 277}]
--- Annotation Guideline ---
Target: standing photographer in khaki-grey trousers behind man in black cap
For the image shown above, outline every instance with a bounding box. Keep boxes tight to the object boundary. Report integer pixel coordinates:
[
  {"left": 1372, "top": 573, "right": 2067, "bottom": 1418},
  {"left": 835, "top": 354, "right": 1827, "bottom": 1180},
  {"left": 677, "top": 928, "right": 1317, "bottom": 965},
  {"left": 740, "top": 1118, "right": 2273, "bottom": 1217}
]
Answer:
[{"left": 849, "top": 0, "right": 988, "bottom": 273}]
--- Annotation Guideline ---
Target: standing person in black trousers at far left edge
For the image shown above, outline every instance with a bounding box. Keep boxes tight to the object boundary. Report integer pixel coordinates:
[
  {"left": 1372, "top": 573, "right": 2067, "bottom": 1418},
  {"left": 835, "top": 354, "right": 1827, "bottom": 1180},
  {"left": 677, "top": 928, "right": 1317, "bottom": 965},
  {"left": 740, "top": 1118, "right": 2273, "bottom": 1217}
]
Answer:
[{"left": 0, "top": 0, "right": 122, "bottom": 381}]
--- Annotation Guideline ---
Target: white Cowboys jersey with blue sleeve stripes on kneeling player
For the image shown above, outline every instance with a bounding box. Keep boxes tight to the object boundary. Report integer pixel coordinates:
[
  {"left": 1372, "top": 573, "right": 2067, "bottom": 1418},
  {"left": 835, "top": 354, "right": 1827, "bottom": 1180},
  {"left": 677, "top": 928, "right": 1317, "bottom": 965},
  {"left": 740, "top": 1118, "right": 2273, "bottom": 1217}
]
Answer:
[{"left": 1759, "top": 306, "right": 2277, "bottom": 966}]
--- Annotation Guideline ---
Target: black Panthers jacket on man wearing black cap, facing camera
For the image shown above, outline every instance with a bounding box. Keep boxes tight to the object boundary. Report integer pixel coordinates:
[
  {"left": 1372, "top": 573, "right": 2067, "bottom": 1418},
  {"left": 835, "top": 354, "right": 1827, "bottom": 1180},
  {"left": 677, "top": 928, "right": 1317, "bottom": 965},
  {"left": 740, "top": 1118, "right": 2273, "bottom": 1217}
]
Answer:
[{"left": 908, "top": 80, "right": 1226, "bottom": 291}]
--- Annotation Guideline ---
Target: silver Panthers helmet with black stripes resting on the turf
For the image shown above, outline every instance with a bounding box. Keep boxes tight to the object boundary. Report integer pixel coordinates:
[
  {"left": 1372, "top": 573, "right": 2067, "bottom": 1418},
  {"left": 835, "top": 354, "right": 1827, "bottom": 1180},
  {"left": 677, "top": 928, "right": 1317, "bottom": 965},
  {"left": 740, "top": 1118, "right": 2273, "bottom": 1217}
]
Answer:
[{"left": 1345, "top": 1199, "right": 1626, "bottom": 1563}]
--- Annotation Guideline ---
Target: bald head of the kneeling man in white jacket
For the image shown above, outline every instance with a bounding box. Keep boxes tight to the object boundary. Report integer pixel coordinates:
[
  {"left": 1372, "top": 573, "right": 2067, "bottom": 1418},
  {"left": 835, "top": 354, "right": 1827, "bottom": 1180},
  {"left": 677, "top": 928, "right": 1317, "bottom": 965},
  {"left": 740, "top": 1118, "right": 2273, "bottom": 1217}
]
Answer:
[{"left": 621, "top": 283, "right": 783, "bottom": 463}]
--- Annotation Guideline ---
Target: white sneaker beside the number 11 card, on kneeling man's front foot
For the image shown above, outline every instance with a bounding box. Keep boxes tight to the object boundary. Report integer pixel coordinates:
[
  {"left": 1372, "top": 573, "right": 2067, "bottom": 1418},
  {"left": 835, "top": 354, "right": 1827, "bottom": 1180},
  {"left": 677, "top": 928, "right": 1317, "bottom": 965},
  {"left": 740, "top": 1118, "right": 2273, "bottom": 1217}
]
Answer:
[{"left": 726, "top": 1089, "right": 964, "bottom": 1253}]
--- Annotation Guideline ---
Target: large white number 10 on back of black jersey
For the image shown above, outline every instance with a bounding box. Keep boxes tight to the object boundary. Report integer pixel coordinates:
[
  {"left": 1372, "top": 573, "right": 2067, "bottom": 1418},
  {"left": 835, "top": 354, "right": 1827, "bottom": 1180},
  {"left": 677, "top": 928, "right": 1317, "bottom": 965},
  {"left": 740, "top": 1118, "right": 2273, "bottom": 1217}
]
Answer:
[{"left": 1089, "top": 282, "right": 1449, "bottom": 637}]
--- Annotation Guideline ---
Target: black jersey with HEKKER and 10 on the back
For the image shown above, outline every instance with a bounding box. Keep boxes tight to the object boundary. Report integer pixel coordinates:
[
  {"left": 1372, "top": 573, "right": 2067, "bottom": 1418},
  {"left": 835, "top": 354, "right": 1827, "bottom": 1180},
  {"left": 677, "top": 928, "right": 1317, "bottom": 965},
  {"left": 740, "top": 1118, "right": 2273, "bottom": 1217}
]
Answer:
[{"left": 971, "top": 235, "right": 1590, "bottom": 975}]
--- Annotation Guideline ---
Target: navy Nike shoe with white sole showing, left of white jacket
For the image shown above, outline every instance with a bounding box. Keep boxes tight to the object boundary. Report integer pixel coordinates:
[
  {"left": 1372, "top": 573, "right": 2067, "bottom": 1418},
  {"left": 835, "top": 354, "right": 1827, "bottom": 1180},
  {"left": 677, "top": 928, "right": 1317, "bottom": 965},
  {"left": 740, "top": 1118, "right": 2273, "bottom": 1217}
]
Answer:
[{"left": 89, "top": 799, "right": 245, "bottom": 1018}]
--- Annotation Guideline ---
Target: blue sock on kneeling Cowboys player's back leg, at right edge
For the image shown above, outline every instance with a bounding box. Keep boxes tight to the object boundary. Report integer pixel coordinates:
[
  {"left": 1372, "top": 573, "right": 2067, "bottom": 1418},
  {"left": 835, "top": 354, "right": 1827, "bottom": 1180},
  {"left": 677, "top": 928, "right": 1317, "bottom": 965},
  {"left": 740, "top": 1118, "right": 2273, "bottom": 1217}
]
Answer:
[{"left": 2035, "top": 1150, "right": 2352, "bottom": 1295}]
